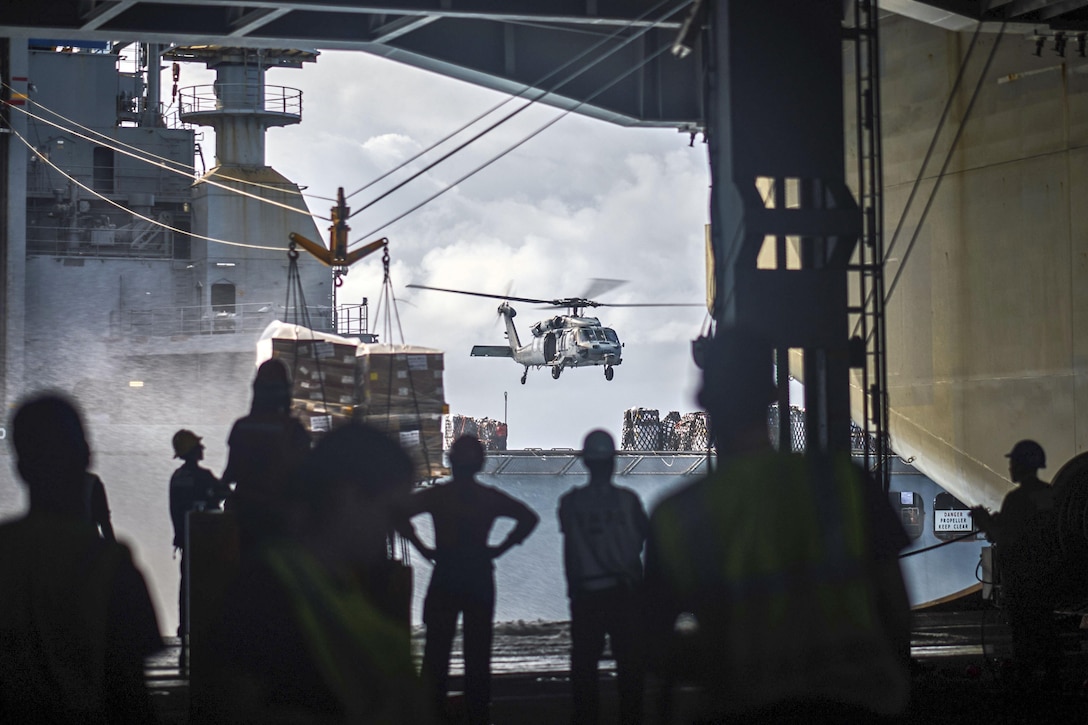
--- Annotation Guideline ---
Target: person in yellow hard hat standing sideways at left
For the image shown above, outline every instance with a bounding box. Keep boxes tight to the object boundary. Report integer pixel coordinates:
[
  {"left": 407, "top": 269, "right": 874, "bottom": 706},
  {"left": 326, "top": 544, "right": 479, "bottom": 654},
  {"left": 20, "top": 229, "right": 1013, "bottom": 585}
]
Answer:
[{"left": 170, "top": 428, "right": 230, "bottom": 635}]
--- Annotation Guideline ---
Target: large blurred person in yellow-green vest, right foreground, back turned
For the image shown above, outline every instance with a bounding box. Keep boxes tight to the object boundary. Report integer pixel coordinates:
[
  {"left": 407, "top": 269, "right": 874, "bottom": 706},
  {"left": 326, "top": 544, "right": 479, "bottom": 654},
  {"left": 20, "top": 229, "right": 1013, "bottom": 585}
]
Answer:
[{"left": 646, "top": 329, "right": 910, "bottom": 723}]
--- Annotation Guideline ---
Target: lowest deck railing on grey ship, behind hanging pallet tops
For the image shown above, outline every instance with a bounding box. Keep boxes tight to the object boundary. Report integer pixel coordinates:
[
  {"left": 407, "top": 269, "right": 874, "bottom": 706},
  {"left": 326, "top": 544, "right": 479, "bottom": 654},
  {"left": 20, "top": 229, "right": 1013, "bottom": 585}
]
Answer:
[{"left": 125, "top": 302, "right": 332, "bottom": 337}]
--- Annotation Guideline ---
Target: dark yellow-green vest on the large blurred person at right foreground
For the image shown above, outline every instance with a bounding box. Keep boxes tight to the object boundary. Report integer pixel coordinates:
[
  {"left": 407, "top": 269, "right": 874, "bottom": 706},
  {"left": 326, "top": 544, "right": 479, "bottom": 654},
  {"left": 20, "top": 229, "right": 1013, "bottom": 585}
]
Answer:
[{"left": 646, "top": 452, "right": 910, "bottom": 714}]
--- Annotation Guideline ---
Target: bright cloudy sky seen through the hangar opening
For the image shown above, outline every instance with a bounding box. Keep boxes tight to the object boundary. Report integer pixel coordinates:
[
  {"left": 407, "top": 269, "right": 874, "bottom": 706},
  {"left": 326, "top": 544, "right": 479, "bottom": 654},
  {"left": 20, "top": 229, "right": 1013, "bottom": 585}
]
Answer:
[{"left": 164, "top": 51, "right": 709, "bottom": 448}]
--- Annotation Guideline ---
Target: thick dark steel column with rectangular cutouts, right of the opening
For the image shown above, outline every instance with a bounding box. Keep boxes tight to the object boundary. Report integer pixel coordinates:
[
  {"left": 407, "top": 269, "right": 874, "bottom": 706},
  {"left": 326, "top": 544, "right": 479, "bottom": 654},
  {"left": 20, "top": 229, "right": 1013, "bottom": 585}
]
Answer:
[{"left": 707, "top": 0, "right": 862, "bottom": 452}]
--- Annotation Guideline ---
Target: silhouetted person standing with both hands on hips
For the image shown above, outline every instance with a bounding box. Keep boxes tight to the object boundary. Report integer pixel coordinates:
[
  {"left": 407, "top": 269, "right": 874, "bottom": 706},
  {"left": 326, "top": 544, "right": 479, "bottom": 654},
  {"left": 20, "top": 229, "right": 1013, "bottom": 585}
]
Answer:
[{"left": 399, "top": 435, "right": 540, "bottom": 724}]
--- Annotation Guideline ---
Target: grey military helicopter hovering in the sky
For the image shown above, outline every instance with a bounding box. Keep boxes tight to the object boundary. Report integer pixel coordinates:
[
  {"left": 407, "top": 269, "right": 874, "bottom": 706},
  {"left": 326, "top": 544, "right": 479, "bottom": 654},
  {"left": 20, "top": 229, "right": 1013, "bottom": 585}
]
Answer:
[{"left": 406, "top": 279, "right": 702, "bottom": 385}]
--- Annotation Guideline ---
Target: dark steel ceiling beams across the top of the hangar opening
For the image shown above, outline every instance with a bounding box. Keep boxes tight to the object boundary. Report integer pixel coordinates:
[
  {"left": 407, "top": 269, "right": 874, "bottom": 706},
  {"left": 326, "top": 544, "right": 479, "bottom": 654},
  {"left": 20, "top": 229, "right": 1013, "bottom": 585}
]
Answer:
[{"left": 0, "top": 0, "right": 1088, "bottom": 127}]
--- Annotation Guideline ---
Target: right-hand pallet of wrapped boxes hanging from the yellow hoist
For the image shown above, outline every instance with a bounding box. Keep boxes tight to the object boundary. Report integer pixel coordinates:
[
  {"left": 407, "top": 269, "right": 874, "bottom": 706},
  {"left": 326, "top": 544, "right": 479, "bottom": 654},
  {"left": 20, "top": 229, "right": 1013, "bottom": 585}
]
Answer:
[{"left": 355, "top": 344, "right": 449, "bottom": 479}]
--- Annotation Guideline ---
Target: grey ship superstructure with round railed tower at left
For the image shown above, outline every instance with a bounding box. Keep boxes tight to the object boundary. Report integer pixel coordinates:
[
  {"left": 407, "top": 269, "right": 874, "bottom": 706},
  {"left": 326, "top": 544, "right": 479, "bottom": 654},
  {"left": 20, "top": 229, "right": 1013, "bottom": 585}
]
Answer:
[{"left": 4, "top": 40, "right": 332, "bottom": 428}]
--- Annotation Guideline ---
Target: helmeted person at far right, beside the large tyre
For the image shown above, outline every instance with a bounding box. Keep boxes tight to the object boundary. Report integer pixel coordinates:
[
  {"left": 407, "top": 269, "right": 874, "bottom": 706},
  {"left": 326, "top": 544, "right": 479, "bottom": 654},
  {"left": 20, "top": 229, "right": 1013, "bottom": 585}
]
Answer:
[{"left": 972, "top": 440, "right": 1061, "bottom": 681}]
